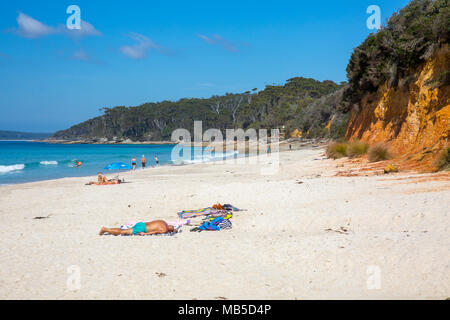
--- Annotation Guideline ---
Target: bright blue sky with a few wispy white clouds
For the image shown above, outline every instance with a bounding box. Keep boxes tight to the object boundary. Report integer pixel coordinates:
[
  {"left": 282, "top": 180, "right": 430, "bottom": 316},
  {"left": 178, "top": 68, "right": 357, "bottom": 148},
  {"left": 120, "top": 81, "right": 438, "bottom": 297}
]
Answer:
[{"left": 0, "top": 0, "right": 409, "bottom": 132}]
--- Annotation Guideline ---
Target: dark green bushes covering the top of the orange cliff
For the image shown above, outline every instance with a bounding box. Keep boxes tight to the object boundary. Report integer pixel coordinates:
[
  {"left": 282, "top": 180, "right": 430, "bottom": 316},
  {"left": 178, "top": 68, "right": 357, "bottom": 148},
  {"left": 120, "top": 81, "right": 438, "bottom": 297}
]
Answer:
[{"left": 342, "top": 0, "right": 450, "bottom": 111}]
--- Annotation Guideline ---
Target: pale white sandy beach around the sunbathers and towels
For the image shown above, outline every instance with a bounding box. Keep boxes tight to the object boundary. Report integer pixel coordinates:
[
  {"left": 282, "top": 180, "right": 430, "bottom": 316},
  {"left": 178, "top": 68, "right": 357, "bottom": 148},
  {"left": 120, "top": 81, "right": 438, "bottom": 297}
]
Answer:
[{"left": 0, "top": 148, "right": 450, "bottom": 299}]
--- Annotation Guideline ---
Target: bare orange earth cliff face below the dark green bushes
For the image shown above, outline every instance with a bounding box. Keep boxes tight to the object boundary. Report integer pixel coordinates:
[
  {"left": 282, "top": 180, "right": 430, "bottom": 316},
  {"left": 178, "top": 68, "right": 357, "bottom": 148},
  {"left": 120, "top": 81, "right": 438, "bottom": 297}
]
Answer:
[{"left": 346, "top": 45, "right": 450, "bottom": 171}]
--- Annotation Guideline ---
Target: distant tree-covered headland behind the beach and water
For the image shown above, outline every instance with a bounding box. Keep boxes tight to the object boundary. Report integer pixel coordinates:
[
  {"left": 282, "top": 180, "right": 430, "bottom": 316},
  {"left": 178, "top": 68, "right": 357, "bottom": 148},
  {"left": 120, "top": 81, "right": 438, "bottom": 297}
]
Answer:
[{"left": 53, "top": 78, "right": 343, "bottom": 141}]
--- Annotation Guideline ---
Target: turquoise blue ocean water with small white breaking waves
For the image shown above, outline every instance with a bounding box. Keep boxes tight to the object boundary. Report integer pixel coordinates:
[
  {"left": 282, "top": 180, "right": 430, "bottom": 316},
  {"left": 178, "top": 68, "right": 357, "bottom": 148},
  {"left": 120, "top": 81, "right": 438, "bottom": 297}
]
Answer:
[{"left": 0, "top": 141, "right": 236, "bottom": 185}]
